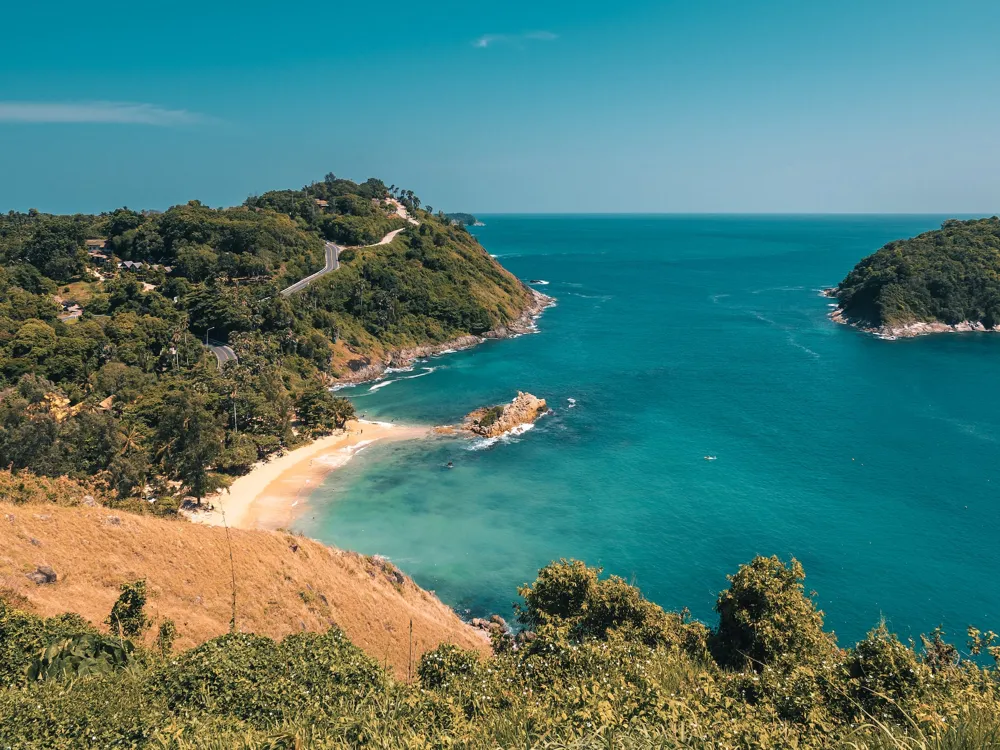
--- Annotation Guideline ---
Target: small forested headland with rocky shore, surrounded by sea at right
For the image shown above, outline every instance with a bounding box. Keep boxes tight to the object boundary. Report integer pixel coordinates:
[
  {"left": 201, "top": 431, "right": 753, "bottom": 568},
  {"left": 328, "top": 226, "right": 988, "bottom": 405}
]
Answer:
[{"left": 831, "top": 216, "right": 1000, "bottom": 335}]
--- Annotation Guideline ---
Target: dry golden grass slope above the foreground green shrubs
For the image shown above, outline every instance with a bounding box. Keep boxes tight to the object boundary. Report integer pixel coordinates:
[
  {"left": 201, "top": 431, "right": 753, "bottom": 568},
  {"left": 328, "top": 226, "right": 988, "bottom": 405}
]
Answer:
[{"left": 0, "top": 503, "right": 489, "bottom": 677}]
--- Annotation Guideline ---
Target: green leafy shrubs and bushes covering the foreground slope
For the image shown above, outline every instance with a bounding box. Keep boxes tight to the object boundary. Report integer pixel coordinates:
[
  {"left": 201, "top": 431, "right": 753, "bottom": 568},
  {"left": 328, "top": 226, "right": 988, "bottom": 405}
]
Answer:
[{"left": 0, "top": 548, "right": 1000, "bottom": 750}]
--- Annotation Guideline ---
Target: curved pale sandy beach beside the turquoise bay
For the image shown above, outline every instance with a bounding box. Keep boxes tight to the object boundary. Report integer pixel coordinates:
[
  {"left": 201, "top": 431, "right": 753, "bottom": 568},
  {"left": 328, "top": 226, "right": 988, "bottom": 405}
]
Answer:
[{"left": 189, "top": 421, "right": 429, "bottom": 529}]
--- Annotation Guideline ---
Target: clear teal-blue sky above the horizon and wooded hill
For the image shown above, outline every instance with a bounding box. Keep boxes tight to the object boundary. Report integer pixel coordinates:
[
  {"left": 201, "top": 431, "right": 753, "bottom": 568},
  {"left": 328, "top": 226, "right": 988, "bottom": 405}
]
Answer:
[{"left": 0, "top": 0, "right": 1000, "bottom": 213}]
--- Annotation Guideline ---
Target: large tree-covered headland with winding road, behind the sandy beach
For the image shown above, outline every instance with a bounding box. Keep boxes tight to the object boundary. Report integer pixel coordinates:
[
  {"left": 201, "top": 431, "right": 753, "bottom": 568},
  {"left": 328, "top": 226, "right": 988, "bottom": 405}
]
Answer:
[{"left": 0, "top": 174, "right": 531, "bottom": 513}]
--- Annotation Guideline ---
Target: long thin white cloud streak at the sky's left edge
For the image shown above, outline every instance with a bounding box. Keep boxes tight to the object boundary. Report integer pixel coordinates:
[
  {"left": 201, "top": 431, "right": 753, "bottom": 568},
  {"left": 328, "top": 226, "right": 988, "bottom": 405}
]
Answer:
[{"left": 0, "top": 100, "right": 206, "bottom": 126}]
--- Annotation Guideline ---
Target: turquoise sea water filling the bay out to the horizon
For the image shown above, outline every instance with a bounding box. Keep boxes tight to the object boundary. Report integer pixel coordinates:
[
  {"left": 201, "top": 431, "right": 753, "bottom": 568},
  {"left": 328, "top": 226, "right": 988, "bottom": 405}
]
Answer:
[{"left": 299, "top": 216, "right": 1000, "bottom": 643}]
